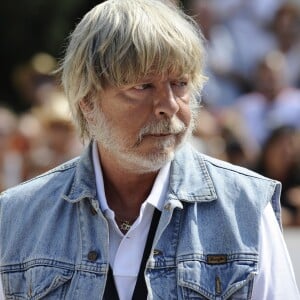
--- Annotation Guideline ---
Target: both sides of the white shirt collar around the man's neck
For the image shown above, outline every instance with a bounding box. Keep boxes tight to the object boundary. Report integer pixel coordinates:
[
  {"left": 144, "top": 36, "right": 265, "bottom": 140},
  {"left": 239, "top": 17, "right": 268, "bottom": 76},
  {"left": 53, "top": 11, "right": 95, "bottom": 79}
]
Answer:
[{"left": 92, "top": 141, "right": 171, "bottom": 214}]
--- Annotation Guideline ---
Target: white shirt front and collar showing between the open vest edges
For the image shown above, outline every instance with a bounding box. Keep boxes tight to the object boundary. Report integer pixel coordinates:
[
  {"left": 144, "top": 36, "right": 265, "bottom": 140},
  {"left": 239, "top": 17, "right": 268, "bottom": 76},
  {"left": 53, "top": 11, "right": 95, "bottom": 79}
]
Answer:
[{"left": 93, "top": 143, "right": 170, "bottom": 300}]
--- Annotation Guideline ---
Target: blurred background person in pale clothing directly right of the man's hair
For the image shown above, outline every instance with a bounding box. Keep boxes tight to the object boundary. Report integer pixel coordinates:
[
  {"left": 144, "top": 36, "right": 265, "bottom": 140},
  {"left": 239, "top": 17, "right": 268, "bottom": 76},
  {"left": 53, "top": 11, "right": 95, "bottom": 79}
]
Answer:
[{"left": 184, "top": 0, "right": 247, "bottom": 110}]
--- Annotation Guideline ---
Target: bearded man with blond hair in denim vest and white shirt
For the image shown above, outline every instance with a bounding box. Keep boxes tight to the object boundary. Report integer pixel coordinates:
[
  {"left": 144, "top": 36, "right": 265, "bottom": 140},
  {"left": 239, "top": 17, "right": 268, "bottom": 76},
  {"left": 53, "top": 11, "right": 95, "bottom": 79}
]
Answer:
[{"left": 0, "top": 0, "right": 298, "bottom": 300}]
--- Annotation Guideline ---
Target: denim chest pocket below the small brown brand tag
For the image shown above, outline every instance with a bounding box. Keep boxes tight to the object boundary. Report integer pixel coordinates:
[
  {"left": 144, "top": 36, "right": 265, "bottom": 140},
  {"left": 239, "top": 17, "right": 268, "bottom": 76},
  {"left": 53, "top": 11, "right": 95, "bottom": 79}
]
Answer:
[{"left": 178, "top": 260, "right": 257, "bottom": 300}]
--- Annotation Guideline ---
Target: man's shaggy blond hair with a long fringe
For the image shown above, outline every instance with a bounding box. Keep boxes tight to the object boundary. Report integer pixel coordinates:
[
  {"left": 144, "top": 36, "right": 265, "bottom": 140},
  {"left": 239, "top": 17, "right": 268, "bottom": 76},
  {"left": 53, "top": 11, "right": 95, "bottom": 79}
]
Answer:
[{"left": 61, "top": 0, "right": 205, "bottom": 138}]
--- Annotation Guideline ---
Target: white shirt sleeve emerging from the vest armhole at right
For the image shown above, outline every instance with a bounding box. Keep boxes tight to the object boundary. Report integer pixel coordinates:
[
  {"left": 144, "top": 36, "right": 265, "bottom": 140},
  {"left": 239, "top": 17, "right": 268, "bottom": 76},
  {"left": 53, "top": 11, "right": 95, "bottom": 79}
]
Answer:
[{"left": 252, "top": 203, "right": 300, "bottom": 300}]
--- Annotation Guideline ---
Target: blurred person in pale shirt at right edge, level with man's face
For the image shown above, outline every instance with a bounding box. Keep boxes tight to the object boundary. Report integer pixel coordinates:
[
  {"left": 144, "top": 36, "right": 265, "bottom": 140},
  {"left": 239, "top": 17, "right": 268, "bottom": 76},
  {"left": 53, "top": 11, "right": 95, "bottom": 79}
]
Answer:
[{"left": 229, "top": 51, "right": 300, "bottom": 147}]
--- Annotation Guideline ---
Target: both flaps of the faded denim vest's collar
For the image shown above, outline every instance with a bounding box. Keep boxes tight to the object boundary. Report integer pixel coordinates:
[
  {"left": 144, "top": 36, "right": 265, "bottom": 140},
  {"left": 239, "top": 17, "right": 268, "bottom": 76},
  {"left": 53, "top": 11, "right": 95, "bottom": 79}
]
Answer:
[{"left": 63, "top": 143, "right": 217, "bottom": 203}]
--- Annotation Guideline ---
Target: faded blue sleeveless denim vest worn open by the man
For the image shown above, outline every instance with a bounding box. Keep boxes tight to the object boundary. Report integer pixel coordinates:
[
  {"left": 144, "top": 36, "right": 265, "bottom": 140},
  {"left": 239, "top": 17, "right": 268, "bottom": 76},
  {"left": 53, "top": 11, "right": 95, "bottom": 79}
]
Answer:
[{"left": 0, "top": 145, "right": 280, "bottom": 300}]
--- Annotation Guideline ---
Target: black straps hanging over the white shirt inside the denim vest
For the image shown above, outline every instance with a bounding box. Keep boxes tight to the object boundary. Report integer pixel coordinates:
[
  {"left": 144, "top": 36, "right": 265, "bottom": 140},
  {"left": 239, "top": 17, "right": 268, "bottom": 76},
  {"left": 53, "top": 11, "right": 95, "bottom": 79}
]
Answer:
[{"left": 103, "top": 208, "right": 161, "bottom": 300}]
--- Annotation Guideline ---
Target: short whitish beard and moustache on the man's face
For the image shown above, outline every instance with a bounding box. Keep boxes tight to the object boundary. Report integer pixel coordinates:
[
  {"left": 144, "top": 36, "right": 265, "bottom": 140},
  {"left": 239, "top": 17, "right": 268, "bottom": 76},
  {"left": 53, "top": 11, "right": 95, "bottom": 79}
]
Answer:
[{"left": 89, "top": 107, "right": 192, "bottom": 174}]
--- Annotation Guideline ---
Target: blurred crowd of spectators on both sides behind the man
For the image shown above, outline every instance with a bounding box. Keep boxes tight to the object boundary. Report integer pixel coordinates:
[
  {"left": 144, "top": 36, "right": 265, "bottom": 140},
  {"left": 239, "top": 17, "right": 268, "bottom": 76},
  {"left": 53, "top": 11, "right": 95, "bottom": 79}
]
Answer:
[{"left": 0, "top": 0, "right": 300, "bottom": 226}]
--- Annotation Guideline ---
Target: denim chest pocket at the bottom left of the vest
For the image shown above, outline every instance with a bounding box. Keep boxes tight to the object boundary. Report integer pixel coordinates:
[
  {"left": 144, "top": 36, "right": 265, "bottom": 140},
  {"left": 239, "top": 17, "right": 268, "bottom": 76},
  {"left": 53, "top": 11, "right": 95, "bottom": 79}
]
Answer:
[{"left": 2, "top": 266, "right": 73, "bottom": 300}]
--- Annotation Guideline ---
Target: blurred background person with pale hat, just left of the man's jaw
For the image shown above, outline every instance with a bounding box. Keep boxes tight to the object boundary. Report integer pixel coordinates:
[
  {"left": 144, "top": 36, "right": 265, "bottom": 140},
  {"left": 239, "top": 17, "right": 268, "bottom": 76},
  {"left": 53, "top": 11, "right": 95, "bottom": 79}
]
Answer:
[{"left": 26, "top": 92, "right": 82, "bottom": 179}]
